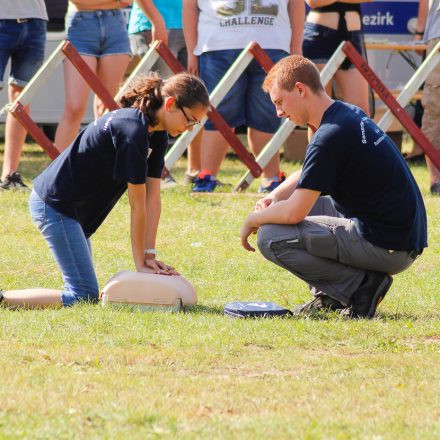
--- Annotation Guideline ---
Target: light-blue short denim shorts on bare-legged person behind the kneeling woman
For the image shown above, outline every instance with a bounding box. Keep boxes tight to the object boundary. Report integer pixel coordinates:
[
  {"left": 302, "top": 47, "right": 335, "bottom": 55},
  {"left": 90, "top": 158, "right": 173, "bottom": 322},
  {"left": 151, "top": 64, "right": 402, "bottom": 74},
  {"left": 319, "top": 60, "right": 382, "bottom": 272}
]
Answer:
[{"left": 66, "top": 9, "right": 131, "bottom": 58}]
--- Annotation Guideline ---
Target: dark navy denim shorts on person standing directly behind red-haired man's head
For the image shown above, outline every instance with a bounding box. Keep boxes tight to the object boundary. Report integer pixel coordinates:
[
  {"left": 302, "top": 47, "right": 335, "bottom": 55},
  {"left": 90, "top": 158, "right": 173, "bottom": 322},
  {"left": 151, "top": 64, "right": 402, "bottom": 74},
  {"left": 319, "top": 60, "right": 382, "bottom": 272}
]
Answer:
[{"left": 302, "top": 22, "right": 364, "bottom": 70}]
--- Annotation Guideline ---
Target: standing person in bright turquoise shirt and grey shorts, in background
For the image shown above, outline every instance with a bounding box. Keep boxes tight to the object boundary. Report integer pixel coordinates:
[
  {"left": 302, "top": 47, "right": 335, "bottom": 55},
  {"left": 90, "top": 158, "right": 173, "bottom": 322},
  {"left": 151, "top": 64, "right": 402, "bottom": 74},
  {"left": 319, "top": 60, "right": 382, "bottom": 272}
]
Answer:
[{"left": 128, "top": 0, "right": 201, "bottom": 183}]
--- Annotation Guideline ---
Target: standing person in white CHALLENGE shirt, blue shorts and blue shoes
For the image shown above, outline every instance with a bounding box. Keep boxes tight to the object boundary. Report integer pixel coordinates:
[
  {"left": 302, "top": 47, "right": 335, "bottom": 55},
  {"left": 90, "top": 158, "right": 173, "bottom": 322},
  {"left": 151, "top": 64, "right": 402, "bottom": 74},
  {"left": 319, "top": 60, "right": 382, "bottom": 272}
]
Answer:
[{"left": 183, "top": 0, "right": 305, "bottom": 192}]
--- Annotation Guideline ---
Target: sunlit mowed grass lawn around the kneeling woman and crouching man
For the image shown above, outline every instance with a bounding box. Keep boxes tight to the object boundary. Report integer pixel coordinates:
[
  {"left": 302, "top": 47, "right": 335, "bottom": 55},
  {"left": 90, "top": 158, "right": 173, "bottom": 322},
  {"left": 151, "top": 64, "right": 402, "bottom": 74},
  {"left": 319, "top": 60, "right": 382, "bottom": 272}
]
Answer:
[{"left": 0, "top": 146, "right": 440, "bottom": 440}]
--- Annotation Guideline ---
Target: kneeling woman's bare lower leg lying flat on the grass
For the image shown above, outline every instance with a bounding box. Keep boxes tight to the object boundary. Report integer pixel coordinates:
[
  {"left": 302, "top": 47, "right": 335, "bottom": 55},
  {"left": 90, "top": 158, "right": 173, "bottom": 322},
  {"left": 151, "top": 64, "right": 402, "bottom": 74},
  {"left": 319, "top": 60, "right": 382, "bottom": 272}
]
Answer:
[{"left": 2, "top": 289, "right": 63, "bottom": 309}]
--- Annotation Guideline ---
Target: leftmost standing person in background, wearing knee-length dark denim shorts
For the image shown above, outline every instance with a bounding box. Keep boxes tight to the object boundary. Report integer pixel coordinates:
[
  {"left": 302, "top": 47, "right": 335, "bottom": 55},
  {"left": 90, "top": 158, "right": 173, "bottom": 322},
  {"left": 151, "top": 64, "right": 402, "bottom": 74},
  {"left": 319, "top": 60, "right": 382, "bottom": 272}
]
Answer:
[{"left": 0, "top": 0, "right": 48, "bottom": 190}]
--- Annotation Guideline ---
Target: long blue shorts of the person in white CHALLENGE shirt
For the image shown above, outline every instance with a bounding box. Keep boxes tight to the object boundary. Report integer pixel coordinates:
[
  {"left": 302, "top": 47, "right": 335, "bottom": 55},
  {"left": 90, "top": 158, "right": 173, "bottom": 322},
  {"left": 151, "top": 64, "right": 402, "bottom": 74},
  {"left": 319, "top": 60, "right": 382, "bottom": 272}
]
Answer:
[{"left": 199, "top": 49, "right": 288, "bottom": 133}]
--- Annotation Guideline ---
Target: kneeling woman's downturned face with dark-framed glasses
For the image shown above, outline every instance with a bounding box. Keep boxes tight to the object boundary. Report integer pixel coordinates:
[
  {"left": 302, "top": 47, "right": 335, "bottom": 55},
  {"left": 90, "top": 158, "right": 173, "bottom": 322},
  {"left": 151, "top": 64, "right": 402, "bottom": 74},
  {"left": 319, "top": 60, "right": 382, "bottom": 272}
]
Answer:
[{"left": 163, "top": 96, "right": 208, "bottom": 136}]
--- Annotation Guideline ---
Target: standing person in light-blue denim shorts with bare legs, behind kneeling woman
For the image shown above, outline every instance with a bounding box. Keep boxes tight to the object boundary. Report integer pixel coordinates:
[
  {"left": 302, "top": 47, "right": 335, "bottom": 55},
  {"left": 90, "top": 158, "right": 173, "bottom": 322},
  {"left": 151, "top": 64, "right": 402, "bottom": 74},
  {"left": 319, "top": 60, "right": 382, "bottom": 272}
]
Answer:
[{"left": 55, "top": 0, "right": 132, "bottom": 151}]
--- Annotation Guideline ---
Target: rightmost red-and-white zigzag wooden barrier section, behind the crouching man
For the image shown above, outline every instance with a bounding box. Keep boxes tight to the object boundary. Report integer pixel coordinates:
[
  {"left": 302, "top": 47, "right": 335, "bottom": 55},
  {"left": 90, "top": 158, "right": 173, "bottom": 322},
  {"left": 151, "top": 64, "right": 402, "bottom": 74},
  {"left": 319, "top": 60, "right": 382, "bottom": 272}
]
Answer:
[{"left": 235, "top": 41, "right": 440, "bottom": 191}]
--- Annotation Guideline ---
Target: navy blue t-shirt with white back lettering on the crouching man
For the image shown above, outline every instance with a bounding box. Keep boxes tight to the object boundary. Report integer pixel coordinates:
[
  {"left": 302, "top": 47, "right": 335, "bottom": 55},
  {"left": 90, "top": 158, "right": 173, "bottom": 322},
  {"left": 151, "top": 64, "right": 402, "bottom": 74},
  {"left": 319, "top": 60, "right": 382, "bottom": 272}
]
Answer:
[{"left": 298, "top": 101, "right": 427, "bottom": 251}]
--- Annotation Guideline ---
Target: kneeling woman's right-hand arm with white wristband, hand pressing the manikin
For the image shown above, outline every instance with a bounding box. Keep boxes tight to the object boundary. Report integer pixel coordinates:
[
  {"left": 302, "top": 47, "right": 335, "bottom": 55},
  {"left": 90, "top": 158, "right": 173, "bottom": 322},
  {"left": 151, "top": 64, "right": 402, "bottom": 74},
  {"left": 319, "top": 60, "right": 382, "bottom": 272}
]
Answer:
[{"left": 144, "top": 177, "right": 178, "bottom": 275}]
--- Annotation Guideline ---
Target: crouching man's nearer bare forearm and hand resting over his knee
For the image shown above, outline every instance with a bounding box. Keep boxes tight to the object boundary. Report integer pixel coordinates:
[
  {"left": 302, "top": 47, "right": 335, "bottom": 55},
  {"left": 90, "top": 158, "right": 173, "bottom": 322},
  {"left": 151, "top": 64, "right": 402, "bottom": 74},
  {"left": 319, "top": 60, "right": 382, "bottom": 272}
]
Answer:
[{"left": 240, "top": 188, "right": 321, "bottom": 252}]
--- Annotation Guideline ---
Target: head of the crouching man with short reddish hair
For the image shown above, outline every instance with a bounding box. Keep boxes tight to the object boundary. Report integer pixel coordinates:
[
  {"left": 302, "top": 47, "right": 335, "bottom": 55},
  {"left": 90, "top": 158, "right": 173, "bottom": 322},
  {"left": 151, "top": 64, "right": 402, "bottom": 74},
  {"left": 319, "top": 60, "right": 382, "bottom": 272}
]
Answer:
[{"left": 263, "top": 55, "right": 326, "bottom": 125}]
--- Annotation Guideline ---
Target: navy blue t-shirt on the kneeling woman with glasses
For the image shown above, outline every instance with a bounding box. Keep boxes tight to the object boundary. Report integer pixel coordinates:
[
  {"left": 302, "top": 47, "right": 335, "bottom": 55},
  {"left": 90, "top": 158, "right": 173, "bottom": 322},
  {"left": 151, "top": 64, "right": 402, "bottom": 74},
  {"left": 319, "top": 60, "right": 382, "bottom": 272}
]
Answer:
[{"left": 34, "top": 108, "right": 168, "bottom": 237}]
